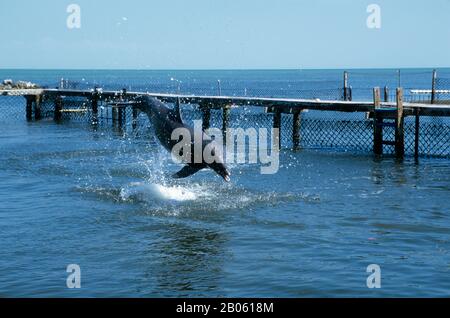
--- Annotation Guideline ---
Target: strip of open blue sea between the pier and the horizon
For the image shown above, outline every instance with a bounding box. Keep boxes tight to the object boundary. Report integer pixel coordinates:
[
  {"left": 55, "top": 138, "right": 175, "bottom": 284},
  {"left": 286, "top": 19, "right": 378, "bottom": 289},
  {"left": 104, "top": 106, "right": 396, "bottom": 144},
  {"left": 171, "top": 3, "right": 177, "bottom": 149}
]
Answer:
[{"left": 5, "top": 68, "right": 450, "bottom": 100}]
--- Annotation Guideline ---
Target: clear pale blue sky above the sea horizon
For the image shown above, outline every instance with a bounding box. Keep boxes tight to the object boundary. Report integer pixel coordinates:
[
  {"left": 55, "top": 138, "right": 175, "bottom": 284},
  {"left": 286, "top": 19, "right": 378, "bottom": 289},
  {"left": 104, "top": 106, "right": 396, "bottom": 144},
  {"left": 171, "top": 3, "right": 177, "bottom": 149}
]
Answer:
[{"left": 0, "top": 0, "right": 450, "bottom": 69}]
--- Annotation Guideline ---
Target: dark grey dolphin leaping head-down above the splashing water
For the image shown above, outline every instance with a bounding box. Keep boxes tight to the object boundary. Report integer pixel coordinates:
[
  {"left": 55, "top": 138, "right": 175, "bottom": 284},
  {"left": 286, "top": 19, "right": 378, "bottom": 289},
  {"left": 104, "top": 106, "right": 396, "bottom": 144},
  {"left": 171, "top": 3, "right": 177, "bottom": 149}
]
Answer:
[{"left": 134, "top": 95, "right": 231, "bottom": 182}]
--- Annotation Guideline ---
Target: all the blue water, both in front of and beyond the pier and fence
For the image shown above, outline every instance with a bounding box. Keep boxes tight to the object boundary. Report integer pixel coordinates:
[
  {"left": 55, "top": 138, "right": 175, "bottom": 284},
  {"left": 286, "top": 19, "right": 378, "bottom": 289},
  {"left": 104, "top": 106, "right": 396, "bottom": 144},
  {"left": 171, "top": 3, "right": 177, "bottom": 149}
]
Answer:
[{"left": 0, "top": 70, "right": 450, "bottom": 297}]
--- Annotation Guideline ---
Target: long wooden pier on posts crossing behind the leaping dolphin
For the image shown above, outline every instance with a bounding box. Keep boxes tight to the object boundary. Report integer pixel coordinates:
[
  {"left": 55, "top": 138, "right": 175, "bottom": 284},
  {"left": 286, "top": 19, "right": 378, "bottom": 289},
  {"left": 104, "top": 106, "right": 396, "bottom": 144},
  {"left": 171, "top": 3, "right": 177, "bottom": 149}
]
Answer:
[{"left": 0, "top": 86, "right": 450, "bottom": 158}]
